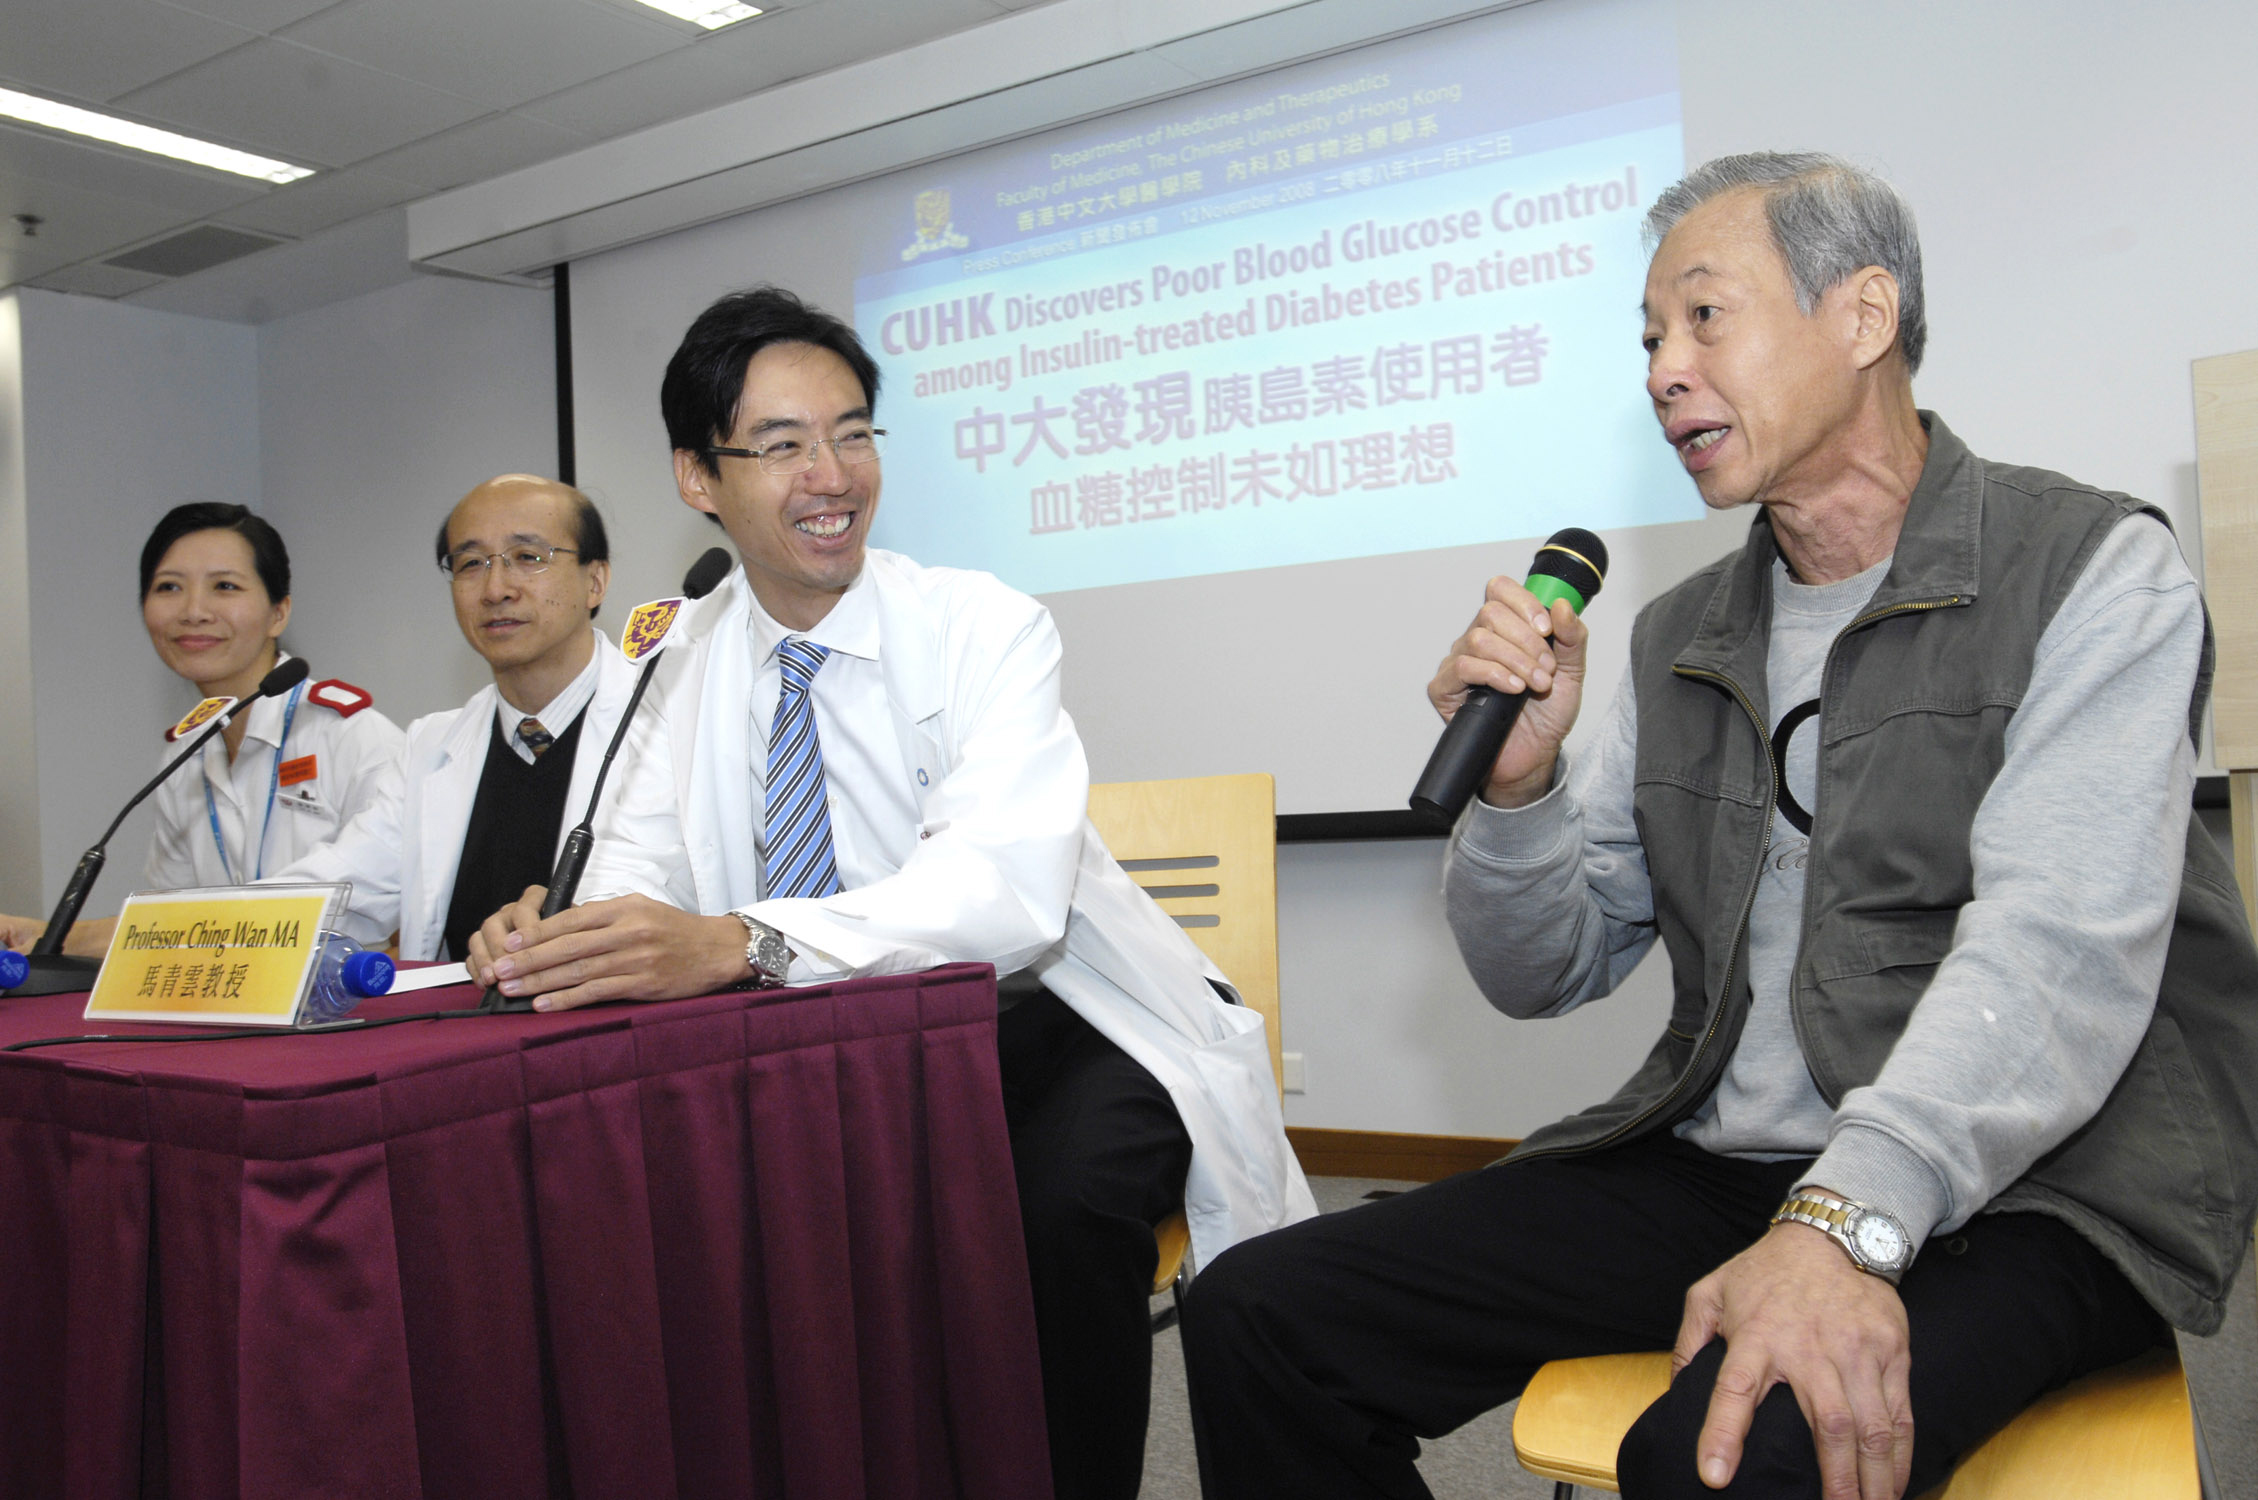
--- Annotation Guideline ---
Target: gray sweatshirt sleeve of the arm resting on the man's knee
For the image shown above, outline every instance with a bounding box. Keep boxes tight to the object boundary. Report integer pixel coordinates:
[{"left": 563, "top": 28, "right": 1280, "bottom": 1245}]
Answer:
[{"left": 1809, "top": 517, "right": 2204, "bottom": 1242}]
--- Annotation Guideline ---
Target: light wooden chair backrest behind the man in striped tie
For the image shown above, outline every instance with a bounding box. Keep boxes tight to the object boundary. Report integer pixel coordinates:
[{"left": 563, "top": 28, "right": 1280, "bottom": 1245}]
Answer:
[{"left": 1091, "top": 775, "right": 1285, "bottom": 1080}]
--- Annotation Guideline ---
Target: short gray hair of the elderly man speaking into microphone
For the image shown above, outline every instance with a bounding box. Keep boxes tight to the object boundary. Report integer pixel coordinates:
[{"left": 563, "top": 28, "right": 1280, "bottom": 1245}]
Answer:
[{"left": 1646, "top": 151, "right": 1928, "bottom": 370}]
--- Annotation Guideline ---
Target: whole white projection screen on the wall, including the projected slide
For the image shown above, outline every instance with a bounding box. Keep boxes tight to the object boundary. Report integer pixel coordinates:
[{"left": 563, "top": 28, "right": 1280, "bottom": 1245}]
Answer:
[{"left": 574, "top": 0, "right": 1741, "bottom": 813}]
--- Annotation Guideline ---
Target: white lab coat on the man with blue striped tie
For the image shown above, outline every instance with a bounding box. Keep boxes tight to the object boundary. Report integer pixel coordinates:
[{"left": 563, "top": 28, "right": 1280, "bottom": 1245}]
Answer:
[{"left": 583, "top": 551, "right": 1316, "bottom": 1265}]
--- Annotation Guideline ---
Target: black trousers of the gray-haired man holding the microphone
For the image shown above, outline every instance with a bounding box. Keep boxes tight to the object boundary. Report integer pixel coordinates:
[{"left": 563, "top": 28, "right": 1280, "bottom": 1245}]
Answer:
[{"left": 1183, "top": 1134, "right": 2170, "bottom": 1500}]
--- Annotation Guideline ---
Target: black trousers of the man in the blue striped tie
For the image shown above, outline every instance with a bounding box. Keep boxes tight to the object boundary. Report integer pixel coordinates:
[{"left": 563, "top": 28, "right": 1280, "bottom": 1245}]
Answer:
[{"left": 996, "top": 989, "right": 1192, "bottom": 1500}]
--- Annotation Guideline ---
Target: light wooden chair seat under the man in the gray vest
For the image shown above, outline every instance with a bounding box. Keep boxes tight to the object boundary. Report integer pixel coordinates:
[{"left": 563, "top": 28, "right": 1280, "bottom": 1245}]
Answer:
[{"left": 1513, "top": 1346, "right": 2204, "bottom": 1500}]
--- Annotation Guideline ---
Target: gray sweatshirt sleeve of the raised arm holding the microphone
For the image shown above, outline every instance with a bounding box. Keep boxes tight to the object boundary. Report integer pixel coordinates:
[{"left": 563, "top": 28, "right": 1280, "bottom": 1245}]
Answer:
[{"left": 1443, "top": 673, "right": 1655, "bottom": 1019}]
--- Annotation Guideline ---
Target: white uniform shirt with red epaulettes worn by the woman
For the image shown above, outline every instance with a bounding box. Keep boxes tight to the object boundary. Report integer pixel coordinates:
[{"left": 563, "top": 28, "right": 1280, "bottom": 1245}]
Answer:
[{"left": 142, "top": 657, "right": 406, "bottom": 942}]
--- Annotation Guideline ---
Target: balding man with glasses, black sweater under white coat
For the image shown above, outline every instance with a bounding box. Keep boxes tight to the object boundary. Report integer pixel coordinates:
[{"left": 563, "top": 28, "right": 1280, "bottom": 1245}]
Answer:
[{"left": 275, "top": 474, "right": 634, "bottom": 958}]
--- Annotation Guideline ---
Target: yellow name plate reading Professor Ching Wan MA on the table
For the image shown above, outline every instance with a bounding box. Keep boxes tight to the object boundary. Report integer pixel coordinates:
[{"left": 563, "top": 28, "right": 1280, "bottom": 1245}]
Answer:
[{"left": 86, "top": 881, "right": 352, "bottom": 1028}]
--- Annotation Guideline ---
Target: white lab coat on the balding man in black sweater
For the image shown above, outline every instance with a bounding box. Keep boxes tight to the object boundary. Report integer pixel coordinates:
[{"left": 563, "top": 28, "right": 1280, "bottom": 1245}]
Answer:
[{"left": 280, "top": 630, "right": 637, "bottom": 958}]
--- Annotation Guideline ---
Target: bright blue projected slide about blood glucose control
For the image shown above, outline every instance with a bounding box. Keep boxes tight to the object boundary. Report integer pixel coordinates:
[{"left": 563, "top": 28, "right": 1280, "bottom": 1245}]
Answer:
[{"left": 856, "top": 5, "right": 1700, "bottom": 592}]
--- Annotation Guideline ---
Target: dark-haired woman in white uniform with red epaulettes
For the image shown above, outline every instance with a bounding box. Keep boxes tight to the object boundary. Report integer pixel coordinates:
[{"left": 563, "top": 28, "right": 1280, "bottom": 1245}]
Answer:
[{"left": 0, "top": 502, "right": 404, "bottom": 953}]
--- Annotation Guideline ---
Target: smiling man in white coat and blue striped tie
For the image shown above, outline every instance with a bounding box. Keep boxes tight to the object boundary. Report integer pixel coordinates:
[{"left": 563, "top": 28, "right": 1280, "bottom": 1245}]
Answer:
[{"left": 472, "top": 287, "right": 1314, "bottom": 1500}]
